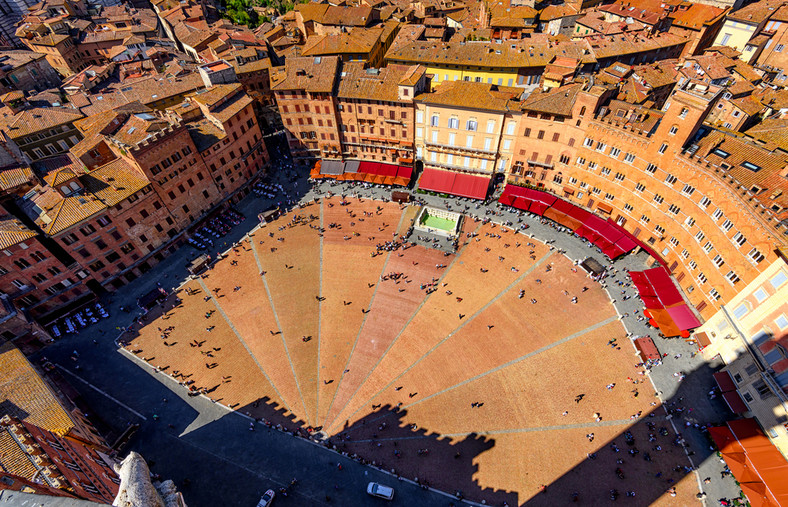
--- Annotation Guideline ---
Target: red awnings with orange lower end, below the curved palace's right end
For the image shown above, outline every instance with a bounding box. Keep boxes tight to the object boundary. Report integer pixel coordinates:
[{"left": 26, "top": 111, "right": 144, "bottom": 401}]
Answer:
[{"left": 629, "top": 266, "right": 700, "bottom": 338}]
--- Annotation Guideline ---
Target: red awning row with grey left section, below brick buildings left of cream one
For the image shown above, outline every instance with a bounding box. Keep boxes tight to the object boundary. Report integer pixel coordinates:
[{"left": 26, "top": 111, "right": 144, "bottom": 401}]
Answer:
[{"left": 309, "top": 160, "right": 413, "bottom": 187}]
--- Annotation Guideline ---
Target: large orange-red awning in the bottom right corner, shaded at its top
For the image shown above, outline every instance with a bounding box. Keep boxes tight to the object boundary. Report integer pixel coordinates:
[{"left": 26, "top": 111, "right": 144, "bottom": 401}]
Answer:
[{"left": 709, "top": 419, "right": 788, "bottom": 507}]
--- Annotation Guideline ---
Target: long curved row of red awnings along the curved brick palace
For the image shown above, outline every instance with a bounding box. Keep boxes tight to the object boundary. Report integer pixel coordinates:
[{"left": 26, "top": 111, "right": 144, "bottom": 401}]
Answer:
[{"left": 498, "top": 185, "right": 638, "bottom": 259}]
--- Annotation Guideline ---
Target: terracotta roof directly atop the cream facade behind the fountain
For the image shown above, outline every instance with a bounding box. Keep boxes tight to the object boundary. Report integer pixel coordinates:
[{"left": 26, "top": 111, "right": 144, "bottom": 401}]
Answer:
[{"left": 415, "top": 81, "right": 522, "bottom": 112}]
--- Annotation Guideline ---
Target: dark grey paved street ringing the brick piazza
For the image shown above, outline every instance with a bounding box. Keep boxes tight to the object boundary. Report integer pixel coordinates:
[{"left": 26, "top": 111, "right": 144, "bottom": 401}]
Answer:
[{"left": 34, "top": 158, "right": 738, "bottom": 506}]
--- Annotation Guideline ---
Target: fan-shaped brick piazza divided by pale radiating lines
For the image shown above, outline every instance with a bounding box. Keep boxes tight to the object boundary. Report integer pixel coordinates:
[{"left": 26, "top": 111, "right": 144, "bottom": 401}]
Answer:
[{"left": 124, "top": 198, "right": 698, "bottom": 505}]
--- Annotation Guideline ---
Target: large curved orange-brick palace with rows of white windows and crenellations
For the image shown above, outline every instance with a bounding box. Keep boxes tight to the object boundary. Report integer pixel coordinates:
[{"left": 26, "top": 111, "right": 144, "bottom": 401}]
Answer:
[{"left": 512, "top": 82, "right": 788, "bottom": 317}]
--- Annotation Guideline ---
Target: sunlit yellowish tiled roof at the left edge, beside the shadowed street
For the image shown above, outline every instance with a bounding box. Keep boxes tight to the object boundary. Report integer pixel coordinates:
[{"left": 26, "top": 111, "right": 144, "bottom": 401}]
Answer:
[{"left": 0, "top": 343, "right": 74, "bottom": 435}]
